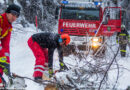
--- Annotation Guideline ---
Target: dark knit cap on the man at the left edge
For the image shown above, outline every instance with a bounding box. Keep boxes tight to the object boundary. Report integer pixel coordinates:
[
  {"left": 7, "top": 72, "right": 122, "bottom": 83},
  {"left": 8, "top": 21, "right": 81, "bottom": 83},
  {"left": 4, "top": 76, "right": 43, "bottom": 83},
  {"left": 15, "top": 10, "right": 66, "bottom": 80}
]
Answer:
[{"left": 5, "top": 4, "right": 21, "bottom": 16}]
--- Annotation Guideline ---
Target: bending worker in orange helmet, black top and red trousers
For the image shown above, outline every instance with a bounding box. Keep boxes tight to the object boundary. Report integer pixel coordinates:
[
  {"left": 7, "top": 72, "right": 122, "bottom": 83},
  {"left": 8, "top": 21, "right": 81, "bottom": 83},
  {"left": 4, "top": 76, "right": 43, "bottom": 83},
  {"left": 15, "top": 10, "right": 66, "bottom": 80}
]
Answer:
[{"left": 28, "top": 33, "right": 70, "bottom": 80}]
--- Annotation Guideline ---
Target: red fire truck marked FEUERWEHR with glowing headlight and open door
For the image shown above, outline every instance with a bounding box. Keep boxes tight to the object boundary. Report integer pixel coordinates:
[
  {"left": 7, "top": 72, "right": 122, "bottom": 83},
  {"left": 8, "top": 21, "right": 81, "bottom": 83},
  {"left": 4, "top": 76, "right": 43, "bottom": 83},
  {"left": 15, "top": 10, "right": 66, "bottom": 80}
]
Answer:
[{"left": 55, "top": 0, "right": 121, "bottom": 55}]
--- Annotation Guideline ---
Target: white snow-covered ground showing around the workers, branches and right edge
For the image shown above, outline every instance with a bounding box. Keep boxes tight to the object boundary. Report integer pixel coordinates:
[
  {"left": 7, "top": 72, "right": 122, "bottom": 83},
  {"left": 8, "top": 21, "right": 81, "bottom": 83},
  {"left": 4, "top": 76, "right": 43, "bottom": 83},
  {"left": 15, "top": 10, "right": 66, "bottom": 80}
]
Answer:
[{"left": 5, "top": 25, "right": 130, "bottom": 90}]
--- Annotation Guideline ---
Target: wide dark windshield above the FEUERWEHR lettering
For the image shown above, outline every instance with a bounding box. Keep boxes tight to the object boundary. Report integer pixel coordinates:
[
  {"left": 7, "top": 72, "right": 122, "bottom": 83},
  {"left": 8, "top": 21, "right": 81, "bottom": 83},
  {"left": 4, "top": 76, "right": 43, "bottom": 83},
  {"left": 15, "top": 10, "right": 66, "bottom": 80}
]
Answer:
[{"left": 61, "top": 7, "right": 100, "bottom": 20}]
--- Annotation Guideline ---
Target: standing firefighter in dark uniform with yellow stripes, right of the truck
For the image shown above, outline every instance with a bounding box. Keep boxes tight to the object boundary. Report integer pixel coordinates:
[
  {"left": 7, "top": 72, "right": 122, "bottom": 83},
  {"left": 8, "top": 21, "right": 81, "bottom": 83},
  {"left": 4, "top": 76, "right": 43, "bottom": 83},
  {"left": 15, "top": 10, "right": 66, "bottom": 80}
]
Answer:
[{"left": 116, "top": 24, "right": 130, "bottom": 57}]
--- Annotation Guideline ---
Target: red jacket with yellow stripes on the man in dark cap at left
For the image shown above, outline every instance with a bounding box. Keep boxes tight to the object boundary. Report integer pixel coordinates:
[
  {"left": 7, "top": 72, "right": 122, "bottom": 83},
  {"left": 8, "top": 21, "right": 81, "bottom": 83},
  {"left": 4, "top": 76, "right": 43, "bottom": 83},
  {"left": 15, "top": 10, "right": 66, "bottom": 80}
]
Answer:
[{"left": 0, "top": 13, "right": 12, "bottom": 63}]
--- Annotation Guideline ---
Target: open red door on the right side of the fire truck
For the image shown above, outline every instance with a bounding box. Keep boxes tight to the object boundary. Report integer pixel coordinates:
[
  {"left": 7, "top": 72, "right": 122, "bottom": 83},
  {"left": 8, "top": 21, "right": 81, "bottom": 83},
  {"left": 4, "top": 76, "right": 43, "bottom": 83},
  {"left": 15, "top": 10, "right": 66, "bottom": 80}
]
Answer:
[{"left": 102, "top": 7, "right": 121, "bottom": 36}]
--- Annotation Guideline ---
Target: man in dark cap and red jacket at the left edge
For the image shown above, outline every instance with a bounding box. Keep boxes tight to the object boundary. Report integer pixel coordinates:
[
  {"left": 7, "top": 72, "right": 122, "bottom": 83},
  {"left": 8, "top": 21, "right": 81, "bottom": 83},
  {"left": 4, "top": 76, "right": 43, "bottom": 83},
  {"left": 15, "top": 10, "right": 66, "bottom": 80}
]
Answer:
[{"left": 0, "top": 4, "right": 20, "bottom": 85}]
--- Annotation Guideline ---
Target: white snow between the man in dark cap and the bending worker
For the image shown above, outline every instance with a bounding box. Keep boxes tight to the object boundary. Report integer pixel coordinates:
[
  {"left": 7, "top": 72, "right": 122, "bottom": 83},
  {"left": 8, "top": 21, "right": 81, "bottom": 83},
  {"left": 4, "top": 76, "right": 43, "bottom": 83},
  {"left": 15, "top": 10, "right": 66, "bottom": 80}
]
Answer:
[{"left": 10, "top": 24, "right": 43, "bottom": 90}]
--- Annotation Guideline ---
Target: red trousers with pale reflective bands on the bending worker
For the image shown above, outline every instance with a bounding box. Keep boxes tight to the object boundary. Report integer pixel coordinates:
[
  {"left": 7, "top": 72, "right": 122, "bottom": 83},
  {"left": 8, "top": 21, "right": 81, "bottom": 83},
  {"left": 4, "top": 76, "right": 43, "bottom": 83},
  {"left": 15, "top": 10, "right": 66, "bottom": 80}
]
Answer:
[{"left": 28, "top": 37, "right": 48, "bottom": 77}]
